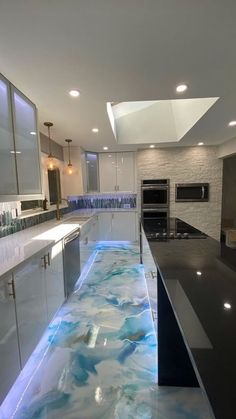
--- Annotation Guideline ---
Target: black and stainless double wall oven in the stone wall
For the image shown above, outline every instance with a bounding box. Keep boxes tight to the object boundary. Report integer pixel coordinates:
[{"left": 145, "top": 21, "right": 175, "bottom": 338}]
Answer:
[{"left": 141, "top": 179, "right": 169, "bottom": 232}]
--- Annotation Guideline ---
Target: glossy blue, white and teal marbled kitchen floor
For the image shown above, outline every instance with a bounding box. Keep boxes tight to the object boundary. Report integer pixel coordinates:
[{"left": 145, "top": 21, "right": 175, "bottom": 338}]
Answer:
[{"left": 1, "top": 243, "right": 212, "bottom": 419}]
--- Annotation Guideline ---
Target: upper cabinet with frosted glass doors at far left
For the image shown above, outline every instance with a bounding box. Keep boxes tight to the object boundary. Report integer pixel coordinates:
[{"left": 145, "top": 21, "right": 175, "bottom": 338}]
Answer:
[{"left": 0, "top": 75, "right": 42, "bottom": 201}]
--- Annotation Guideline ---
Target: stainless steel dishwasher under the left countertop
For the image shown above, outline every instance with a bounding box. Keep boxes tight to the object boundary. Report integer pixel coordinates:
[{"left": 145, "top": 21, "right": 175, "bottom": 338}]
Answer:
[{"left": 64, "top": 228, "right": 80, "bottom": 298}]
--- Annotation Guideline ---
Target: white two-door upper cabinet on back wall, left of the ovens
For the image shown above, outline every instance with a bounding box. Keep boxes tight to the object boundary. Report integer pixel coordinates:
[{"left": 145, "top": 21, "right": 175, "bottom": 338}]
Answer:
[{"left": 99, "top": 152, "right": 135, "bottom": 192}]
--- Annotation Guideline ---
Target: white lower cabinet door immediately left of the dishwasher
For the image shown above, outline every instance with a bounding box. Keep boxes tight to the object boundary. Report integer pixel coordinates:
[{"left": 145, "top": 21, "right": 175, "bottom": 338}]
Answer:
[{"left": 44, "top": 241, "right": 65, "bottom": 322}]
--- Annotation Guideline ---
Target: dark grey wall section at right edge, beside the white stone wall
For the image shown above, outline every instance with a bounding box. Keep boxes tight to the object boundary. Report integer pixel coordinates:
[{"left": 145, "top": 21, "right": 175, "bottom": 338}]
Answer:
[{"left": 222, "top": 156, "right": 236, "bottom": 227}]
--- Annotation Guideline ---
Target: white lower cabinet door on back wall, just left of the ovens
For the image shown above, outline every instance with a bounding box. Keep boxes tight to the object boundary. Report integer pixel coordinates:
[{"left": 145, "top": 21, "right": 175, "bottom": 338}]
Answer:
[{"left": 112, "top": 212, "right": 136, "bottom": 241}]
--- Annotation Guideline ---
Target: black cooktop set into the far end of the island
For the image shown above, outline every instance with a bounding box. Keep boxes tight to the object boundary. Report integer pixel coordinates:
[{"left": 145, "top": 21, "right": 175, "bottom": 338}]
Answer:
[{"left": 143, "top": 218, "right": 207, "bottom": 241}]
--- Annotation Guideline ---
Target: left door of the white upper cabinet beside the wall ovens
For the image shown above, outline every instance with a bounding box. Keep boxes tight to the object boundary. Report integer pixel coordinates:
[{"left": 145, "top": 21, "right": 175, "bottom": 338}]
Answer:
[{"left": 99, "top": 153, "right": 117, "bottom": 192}]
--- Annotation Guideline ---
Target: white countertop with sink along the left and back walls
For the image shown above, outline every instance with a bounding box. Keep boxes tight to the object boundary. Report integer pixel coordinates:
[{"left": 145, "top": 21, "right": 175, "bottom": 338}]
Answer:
[{"left": 0, "top": 208, "right": 137, "bottom": 279}]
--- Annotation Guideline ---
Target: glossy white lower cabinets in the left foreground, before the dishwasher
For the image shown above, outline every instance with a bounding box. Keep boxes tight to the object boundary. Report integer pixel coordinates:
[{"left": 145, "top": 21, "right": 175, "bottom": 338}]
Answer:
[{"left": 0, "top": 241, "right": 65, "bottom": 404}]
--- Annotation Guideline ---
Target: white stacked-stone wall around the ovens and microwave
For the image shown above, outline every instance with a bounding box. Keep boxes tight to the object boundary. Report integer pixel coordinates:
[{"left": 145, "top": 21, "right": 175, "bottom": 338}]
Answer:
[{"left": 137, "top": 147, "right": 222, "bottom": 240}]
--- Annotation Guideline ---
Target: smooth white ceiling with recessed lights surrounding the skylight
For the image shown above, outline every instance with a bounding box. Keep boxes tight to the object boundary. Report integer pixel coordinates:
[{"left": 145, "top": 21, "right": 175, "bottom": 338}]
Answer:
[{"left": 0, "top": 0, "right": 236, "bottom": 151}]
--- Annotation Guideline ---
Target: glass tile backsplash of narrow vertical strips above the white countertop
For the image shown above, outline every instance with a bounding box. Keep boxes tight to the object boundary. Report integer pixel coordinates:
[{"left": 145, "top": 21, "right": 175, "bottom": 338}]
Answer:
[{"left": 0, "top": 194, "right": 136, "bottom": 238}]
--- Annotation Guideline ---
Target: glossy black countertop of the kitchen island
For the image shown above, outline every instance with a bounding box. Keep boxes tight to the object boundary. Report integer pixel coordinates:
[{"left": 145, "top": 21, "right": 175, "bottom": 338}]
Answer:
[{"left": 149, "top": 220, "right": 236, "bottom": 419}]
